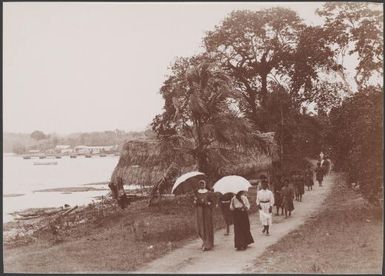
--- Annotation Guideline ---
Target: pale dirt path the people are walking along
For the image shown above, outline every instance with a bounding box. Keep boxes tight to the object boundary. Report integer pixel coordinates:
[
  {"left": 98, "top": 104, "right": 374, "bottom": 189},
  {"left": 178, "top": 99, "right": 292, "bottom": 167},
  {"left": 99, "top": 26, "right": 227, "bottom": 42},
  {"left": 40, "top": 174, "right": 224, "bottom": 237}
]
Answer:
[{"left": 137, "top": 173, "right": 334, "bottom": 273}]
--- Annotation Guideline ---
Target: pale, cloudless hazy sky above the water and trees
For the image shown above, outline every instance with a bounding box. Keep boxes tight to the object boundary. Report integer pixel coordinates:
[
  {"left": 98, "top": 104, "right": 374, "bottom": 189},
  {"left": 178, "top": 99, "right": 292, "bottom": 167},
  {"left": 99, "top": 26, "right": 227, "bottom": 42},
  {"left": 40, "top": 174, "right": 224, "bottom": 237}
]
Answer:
[{"left": 3, "top": 2, "right": 321, "bottom": 133}]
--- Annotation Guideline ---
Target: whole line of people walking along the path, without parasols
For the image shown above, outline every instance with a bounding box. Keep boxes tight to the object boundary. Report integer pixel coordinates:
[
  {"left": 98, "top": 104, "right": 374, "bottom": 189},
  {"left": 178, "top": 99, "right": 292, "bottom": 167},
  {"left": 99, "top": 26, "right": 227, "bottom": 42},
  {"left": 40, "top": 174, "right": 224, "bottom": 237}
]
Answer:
[{"left": 194, "top": 155, "right": 330, "bottom": 251}]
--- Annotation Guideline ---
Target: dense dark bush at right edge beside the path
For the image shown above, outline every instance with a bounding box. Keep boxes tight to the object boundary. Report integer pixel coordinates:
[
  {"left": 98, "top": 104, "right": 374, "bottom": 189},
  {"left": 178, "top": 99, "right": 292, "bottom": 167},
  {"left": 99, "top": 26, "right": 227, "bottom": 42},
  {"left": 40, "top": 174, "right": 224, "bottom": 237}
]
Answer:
[{"left": 328, "top": 87, "right": 383, "bottom": 203}]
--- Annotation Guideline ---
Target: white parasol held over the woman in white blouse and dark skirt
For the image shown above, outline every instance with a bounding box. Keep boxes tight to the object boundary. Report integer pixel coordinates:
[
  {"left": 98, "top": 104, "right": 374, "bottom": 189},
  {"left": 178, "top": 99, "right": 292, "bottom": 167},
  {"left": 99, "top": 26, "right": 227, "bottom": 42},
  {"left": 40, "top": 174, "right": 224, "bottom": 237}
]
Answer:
[{"left": 213, "top": 175, "right": 251, "bottom": 194}]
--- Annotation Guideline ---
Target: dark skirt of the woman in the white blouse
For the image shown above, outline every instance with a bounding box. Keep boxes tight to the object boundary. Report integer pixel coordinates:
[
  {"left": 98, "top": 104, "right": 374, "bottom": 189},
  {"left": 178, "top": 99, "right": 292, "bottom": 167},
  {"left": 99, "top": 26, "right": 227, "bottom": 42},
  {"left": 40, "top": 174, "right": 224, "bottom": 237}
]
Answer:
[{"left": 233, "top": 209, "right": 254, "bottom": 248}]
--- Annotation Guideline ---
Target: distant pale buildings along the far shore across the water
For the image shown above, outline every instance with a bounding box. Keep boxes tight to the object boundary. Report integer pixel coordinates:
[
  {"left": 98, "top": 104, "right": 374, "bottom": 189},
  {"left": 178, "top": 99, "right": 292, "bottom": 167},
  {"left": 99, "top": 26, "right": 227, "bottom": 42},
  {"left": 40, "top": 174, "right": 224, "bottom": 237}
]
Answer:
[{"left": 23, "top": 145, "right": 119, "bottom": 159}]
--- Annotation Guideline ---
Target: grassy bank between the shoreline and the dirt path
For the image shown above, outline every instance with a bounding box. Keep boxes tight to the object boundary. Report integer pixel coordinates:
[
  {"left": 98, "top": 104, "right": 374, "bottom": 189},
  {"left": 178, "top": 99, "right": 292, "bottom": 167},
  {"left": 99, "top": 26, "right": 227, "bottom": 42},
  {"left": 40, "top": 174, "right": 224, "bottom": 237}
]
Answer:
[{"left": 4, "top": 193, "right": 228, "bottom": 273}]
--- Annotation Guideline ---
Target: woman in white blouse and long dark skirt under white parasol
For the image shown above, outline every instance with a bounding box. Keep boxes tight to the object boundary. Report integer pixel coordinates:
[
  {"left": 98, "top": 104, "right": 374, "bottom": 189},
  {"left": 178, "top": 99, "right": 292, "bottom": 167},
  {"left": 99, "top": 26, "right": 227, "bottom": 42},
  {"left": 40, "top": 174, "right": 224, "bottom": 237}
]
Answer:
[{"left": 230, "top": 191, "right": 254, "bottom": 250}]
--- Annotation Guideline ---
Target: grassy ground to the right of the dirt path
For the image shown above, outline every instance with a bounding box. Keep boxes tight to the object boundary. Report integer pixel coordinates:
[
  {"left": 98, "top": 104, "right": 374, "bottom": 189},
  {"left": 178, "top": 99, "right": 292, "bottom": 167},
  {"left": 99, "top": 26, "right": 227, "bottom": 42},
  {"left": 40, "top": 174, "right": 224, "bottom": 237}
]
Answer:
[{"left": 249, "top": 175, "right": 383, "bottom": 273}]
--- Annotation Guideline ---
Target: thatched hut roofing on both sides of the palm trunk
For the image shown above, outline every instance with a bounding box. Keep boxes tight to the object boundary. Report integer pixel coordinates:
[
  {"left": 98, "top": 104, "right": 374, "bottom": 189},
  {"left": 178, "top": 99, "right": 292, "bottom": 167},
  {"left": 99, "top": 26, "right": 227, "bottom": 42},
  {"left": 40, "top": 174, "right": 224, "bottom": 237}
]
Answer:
[{"left": 111, "top": 132, "right": 278, "bottom": 192}]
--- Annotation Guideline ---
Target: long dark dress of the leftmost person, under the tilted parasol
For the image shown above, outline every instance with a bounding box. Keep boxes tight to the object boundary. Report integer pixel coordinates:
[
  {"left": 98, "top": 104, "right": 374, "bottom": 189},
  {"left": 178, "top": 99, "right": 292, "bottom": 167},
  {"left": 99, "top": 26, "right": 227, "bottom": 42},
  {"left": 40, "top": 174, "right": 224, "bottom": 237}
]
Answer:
[{"left": 195, "top": 191, "right": 215, "bottom": 250}]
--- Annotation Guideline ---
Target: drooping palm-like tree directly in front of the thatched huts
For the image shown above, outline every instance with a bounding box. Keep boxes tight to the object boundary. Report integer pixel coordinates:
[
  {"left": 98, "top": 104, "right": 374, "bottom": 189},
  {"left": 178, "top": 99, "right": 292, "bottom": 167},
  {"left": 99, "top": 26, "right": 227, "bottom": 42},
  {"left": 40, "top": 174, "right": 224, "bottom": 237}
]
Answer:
[{"left": 152, "top": 55, "right": 272, "bottom": 178}]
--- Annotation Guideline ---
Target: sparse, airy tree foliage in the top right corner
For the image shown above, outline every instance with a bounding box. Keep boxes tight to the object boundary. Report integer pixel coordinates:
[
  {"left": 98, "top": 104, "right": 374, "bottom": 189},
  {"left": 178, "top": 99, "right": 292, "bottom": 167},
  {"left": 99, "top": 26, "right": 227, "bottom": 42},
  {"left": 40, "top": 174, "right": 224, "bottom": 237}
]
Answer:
[{"left": 317, "top": 2, "right": 384, "bottom": 89}]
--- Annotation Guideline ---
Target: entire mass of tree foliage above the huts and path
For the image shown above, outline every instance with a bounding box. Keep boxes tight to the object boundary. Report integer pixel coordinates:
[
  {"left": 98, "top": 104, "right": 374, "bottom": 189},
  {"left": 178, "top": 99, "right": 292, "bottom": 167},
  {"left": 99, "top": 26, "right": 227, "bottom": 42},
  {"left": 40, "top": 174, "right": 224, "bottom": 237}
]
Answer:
[{"left": 152, "top": 2, "right": 383, "bottom": 201}]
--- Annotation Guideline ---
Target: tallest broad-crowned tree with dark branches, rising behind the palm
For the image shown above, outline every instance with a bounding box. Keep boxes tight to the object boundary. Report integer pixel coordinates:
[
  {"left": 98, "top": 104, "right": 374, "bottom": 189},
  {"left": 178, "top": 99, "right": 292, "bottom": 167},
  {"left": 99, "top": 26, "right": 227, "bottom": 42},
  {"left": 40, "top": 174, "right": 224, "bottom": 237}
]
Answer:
[{"left": 204, "top": 8, "right": 334, "bottom": 130}]
